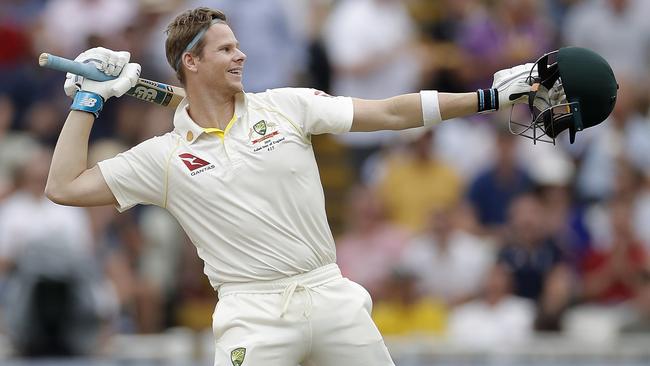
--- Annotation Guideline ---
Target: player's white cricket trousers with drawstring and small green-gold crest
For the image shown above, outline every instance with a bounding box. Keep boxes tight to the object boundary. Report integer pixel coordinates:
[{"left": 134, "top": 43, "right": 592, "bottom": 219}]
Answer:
[{"left": 212, "top": 263, "right": 394, "bottom": 366}]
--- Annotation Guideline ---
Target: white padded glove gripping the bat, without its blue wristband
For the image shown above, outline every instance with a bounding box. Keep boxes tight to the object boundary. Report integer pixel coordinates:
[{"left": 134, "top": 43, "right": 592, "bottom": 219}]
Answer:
[{"left": 63, "top": 47, "right": 140, "bottom": 101}]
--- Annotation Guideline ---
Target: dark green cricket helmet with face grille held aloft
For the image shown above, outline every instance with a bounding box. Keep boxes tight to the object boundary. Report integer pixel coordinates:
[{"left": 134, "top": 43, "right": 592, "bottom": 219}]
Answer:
[{"left": 512, "top": 47, "right": 618, "bottom": 143}]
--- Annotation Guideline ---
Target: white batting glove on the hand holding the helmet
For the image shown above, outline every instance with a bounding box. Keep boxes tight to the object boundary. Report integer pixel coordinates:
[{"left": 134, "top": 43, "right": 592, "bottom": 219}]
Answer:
[{"left": 492, "top": 63, "right": 538, "bottom": 109}]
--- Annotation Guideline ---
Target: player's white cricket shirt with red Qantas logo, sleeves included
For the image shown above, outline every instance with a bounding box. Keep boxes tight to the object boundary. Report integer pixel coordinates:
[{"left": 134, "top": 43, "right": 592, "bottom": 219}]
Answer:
[{"left": 98, "top": 88, "right": 353, "bottom": 288}]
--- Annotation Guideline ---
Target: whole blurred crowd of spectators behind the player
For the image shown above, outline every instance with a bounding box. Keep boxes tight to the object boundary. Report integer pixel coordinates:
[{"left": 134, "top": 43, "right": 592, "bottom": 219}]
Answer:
[{"left": 0, "top": 0, "right": 650, "bottom": 356}]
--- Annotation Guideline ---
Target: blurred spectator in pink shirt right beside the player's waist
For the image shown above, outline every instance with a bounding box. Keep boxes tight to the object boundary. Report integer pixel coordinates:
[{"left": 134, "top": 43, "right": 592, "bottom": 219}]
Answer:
[{"left": 336, "top": 186, "right": 409, "bottom": 299}]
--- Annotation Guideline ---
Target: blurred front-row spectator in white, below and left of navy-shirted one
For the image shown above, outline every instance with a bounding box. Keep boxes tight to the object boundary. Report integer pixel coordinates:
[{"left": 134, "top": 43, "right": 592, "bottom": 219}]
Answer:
[{"left": 449, "top": 265, "right": 535, "bottom": 350}]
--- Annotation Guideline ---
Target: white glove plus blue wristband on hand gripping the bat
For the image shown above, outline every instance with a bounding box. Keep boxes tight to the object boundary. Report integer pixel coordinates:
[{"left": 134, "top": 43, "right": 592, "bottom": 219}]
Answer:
[{"left": 63, "top": 47, "right": 140, "bottom": 117}]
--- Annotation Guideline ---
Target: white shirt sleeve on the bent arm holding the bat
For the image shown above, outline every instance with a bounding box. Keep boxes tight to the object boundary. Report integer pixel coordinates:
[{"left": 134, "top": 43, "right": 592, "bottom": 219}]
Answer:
[{"left": 97, "top": 136, "right": 169, "bottom": 212}]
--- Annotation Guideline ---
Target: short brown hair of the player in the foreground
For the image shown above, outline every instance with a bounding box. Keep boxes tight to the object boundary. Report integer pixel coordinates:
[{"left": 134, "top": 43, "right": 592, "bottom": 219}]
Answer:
[{"left": 165, "top": 7, "right": 226, "bottom": 85}]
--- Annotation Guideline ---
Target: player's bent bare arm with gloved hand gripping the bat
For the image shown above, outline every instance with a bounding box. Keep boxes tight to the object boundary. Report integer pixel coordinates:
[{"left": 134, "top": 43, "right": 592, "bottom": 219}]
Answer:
[{"left": 45, "top": 48, "right": 140, "bottom": 206}]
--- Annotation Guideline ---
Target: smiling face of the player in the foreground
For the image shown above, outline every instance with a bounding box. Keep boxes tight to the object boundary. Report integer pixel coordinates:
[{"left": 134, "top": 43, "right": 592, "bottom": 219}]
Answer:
[{"left": 192, "top": 23, "right": 246, "bottom": 94}]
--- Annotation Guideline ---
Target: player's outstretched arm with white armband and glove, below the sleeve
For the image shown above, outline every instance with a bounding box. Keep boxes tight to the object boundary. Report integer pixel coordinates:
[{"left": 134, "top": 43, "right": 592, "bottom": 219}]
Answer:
[{"left": 351, "top": 64, "right": 532, "bottom": 131}]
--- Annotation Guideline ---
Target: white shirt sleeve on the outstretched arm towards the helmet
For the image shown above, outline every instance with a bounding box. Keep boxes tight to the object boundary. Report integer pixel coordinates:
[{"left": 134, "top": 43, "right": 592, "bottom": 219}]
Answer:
[{"left": 262, "top": 88, "right": 354, "bottom": 136}]
